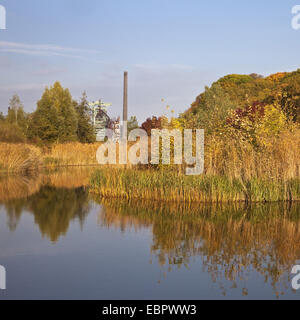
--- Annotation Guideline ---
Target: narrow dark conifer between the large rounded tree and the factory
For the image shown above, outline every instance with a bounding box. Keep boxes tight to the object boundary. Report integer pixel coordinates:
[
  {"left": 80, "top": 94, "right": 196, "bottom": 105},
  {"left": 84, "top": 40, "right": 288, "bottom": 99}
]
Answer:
[{"left": 74, "top": 92, "right": 96, "bottom": 143}]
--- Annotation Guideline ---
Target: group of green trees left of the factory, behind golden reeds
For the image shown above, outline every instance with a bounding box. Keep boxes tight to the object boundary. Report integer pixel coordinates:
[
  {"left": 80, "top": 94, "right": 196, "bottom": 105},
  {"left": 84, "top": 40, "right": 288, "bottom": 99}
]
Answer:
[{"left": 0, "top": 82, "right": 96, "bottom": 143}]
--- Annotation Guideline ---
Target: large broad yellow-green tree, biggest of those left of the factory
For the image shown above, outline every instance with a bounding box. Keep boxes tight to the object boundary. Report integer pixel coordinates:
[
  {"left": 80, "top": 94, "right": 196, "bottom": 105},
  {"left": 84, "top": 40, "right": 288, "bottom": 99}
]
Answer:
[{"left": 29, "top": 82, "right": 78, "bottom": 142}]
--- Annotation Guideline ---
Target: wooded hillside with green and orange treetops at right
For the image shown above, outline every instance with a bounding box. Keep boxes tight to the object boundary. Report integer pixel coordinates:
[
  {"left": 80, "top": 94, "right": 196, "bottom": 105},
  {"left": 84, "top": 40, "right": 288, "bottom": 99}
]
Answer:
[{"left": 180, "top": 69, "right": 300, "bottom": 135}]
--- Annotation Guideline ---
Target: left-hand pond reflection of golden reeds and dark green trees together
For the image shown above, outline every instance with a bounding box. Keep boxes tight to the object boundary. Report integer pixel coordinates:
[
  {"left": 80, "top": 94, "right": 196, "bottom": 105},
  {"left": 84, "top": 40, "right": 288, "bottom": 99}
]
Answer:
[{"left": 0, "top": 167, "right": 94, "bottom": 241}]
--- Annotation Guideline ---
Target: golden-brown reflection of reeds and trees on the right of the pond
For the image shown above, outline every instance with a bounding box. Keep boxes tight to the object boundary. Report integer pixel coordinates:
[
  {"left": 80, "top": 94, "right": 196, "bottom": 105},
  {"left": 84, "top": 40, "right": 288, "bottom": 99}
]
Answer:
[{"left": 100, "top": 203, "right": 300, "bottom": 295}]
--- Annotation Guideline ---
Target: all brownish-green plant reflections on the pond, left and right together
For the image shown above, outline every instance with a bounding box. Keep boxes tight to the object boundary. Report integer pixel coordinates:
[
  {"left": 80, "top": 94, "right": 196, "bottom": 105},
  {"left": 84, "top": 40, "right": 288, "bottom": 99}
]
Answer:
[{"left": 0, "top": 170, "right": 300, "bottom": 296}]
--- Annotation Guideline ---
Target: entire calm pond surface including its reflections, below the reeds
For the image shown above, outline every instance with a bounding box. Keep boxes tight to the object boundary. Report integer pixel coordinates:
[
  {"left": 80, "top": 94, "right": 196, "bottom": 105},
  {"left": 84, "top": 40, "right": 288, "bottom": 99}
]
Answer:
[{"left": 0, "top": 170, "right": 300, "bottom": 299}]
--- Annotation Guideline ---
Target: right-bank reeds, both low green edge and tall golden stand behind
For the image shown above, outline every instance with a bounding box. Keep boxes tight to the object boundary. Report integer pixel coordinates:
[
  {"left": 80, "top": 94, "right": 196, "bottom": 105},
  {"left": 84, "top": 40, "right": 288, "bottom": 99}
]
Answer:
[{"left": 91, "top": 128, "right": 300, "bottom": 202}]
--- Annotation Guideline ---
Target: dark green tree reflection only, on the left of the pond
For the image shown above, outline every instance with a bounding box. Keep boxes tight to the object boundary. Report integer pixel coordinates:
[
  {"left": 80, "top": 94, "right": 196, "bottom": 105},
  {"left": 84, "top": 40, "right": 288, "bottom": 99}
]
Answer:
[{"left": 5, "top": 185, "right": 90, "bottom": 242}]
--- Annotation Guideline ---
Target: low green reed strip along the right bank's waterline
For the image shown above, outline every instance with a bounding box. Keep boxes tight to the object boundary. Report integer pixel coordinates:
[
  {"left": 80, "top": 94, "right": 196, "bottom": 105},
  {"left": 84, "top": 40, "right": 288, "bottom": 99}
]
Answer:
[{"left": 90, "top": 168, "right": 300, "bottom": 202}]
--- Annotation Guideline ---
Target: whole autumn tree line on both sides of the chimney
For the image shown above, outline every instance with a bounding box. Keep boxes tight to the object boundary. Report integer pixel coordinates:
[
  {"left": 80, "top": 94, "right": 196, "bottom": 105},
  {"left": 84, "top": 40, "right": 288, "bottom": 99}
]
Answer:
[{"left": 0, "top": 69, "right": 300, "bottom": 145}]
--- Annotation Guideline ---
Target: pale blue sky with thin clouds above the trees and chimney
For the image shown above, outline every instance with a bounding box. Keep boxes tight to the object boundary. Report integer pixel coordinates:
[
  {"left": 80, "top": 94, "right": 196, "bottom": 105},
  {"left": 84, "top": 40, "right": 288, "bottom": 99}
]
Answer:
[{"left": 0, "top": 0, "right": 300, "bottom": 121}]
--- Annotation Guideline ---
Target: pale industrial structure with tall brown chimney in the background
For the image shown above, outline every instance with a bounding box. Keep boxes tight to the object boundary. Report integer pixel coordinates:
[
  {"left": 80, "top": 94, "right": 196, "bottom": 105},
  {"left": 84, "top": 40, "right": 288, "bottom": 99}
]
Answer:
[{"left": 89, "top": 72, "right": 128, "bottom": 141}]
